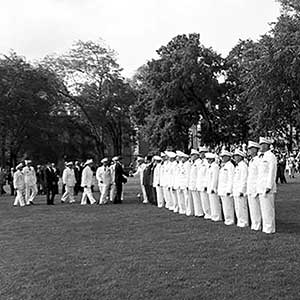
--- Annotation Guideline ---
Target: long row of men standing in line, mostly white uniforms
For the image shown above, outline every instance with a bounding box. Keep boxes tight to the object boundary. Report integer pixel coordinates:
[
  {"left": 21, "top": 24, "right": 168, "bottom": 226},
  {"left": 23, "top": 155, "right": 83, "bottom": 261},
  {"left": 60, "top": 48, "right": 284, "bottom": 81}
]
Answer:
[{"left": 135, "top": 137, "right": 277, "bottom": 233}]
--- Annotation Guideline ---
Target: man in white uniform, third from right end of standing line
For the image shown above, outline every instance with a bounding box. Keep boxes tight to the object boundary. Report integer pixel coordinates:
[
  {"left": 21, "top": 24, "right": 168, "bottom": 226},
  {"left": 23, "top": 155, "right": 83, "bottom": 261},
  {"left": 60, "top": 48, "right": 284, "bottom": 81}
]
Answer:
[{"left": 233, "top": 149, "right": 249, "bottom": 227}]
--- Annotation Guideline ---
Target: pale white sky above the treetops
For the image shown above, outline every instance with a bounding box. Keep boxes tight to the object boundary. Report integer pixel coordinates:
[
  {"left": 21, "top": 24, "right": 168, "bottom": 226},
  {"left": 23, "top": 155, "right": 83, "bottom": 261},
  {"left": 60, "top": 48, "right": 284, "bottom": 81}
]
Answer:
[{"left": 0, "top": 0, "right": 280, "bottom": 76}]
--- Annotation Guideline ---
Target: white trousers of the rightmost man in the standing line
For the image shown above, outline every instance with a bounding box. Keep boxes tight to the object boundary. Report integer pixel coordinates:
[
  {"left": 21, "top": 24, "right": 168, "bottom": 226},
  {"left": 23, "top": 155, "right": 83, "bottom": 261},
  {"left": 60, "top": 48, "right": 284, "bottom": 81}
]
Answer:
[{"left": 259, "top": 193, "right": 275, "bottom": 233}]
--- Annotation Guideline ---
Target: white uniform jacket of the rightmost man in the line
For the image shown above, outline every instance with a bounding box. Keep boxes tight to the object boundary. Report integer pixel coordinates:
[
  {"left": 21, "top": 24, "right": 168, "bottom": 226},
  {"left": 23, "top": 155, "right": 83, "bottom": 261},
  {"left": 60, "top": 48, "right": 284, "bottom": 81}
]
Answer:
[{"left": 257, "top": 150, "right": 277, "bottom": 194}]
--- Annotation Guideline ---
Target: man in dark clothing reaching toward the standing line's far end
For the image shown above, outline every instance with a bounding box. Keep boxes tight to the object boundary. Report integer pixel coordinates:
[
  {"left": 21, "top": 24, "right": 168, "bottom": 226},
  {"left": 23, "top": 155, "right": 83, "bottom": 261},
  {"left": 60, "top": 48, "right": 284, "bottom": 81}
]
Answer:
[{"left": 112, "top": 156, "right": 129, "bottom": 204}]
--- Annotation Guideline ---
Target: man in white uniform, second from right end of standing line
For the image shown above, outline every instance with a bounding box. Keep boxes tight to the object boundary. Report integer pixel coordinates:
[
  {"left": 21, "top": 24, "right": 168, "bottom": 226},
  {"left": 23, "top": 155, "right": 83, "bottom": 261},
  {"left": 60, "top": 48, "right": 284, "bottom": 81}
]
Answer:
[{"left": 247, "top": 141, "right": 261, "bottom": 230}]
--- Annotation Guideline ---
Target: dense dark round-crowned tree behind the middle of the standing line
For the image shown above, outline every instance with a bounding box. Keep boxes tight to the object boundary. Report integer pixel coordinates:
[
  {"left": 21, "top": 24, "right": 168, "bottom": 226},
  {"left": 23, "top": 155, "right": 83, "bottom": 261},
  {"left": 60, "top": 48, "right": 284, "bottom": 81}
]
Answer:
[{"left": 133, "top": 34, "right": 223, "bottom": 150}]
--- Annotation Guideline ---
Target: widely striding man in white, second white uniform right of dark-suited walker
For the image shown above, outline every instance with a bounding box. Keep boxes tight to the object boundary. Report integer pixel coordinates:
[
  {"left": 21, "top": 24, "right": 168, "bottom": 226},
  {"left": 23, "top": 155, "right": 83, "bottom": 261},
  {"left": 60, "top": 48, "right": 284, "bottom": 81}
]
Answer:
[{"left": 81, "top": 159, "right": 96, "bottom": 205}]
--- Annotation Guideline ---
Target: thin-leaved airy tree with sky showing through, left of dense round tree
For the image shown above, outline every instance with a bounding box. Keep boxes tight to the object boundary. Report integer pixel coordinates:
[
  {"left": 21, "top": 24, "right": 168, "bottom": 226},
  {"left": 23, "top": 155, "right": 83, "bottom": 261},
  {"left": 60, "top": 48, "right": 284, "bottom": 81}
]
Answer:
[{"left": 44, "top": 41, "right": 135, "bottom": 156}]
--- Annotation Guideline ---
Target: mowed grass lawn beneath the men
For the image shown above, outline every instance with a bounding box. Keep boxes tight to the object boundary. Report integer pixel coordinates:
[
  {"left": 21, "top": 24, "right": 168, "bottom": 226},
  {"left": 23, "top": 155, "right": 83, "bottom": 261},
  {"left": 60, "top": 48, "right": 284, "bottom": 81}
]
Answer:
[{"left": 0, "top": 178, "right": 300, "bottom": 300}]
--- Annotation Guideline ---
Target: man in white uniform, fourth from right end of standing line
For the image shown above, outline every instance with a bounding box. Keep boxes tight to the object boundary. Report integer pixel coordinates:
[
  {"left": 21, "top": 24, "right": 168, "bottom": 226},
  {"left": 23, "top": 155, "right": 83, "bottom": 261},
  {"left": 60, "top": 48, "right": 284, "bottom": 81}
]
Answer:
[{"left": 218, "top": 150, "right": 234, "bottom": 225}]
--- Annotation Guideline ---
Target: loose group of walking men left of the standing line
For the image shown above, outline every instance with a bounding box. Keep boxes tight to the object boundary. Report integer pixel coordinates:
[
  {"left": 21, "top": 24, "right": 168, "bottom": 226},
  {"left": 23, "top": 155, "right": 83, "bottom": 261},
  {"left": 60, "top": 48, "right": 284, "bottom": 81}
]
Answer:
[{"left": 13, "top": 156, "right": 129, "bottom": 207}]
